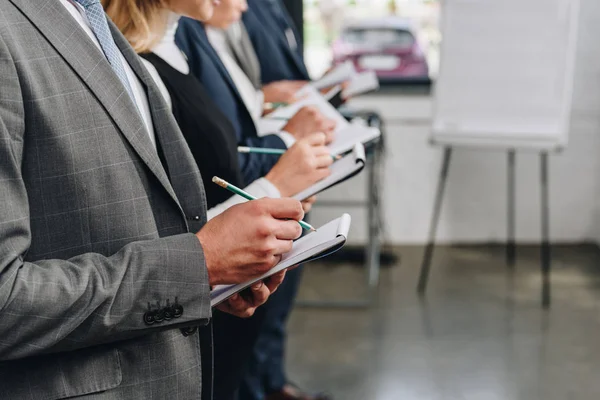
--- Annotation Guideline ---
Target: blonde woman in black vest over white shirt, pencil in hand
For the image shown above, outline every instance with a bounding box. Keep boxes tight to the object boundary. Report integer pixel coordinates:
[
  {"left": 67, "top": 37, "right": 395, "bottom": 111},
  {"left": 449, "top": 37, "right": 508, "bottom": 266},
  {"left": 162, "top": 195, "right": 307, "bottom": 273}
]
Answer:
[{"left": 102, "top": 0, "right": 332, "bottom": 218}]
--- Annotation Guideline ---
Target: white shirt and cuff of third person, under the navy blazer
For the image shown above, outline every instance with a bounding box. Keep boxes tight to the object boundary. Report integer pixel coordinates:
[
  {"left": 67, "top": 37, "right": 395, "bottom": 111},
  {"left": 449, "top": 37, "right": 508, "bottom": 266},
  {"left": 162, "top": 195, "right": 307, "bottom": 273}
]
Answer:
[{"left": 205, "top": 25, "right": 296, "bottom": 148}]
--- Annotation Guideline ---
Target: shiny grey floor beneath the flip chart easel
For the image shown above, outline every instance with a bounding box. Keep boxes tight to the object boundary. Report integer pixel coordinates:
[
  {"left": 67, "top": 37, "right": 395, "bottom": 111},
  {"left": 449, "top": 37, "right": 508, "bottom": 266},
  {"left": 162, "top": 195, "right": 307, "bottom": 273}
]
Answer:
[{"left": 288, "top": 246, "right": 600, "bottom": 400}]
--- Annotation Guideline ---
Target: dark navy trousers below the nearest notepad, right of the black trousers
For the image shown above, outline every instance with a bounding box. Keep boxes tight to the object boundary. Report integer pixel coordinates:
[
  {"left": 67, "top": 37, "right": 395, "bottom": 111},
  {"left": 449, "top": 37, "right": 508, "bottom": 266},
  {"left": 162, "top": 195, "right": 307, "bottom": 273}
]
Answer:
[{"left": 238, "top": 267, "right": 302, "bottom": 400}]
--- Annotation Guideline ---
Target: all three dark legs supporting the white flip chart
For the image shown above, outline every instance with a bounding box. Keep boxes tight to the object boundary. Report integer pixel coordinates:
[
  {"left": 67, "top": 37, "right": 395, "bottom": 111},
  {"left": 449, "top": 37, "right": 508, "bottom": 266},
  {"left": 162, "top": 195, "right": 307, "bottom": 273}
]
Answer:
[{"left": 417, "top": 147, "right": 551, "bottom": 308}]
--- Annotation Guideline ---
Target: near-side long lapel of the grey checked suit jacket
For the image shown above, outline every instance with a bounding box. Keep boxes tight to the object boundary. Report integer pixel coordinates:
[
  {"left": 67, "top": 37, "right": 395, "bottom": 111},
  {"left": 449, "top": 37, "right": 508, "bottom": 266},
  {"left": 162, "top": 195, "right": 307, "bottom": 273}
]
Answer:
[{"left": 10, "top": 0, "right": 177, "bottom": 208}]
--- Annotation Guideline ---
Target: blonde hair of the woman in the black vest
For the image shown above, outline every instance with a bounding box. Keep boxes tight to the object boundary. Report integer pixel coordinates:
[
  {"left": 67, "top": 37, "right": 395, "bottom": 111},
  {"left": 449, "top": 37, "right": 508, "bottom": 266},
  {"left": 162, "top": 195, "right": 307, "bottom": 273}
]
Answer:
[{"left": 102, "top": 0, "right": 168, "bottom": 53}]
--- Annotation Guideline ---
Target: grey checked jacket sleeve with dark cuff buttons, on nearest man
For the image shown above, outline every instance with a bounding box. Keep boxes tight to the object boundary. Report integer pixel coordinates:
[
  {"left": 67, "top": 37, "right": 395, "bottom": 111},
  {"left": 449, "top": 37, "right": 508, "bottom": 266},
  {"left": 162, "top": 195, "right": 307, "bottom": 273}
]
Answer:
[{"left": 0, "top": 29, "right": 211, "bottom": 361}]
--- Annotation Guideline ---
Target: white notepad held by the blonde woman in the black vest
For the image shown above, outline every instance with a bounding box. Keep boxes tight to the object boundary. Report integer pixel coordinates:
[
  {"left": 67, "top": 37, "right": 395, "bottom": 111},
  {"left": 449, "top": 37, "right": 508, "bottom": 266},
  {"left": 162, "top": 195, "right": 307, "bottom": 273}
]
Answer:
[{"left": 294, "top": 143, "right": 366, "bottom": 201}]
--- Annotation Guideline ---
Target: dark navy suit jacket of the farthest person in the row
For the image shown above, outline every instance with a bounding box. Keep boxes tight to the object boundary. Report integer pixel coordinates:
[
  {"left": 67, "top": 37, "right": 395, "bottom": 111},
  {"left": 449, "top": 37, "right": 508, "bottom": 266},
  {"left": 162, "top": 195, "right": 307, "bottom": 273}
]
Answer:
[{"left": 243, "top": 0, "right": 310, "bottom": 83}]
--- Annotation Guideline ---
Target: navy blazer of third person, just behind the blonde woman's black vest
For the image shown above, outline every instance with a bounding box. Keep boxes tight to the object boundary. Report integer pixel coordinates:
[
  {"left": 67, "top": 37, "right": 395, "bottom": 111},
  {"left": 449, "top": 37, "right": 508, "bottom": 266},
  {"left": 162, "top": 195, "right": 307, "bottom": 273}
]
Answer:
[{"left": 176, "top": 18, "right": 286, "bottom": 184}]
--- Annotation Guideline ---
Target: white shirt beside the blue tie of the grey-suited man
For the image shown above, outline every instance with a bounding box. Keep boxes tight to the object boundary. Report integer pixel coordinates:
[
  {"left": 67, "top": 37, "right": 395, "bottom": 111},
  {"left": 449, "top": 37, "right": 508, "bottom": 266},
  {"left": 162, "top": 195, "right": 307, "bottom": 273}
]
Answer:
[{"left": 60, "top": 0, "right": 156, "bottom": 148}]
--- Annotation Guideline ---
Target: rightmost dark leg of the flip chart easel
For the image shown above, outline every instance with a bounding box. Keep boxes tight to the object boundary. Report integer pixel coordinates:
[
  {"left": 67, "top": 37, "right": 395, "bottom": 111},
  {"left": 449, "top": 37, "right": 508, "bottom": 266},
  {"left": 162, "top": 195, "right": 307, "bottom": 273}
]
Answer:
[{"left": 540, "top": 153, "right": 551, "bottom": 308}]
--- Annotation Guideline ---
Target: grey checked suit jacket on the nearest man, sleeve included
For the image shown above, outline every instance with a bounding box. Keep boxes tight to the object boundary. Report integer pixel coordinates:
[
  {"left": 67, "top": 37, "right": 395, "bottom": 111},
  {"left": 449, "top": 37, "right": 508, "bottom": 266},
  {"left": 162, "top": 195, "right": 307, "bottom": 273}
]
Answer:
[{"left": 0, "top": 0, "right": 211, "bottom": 400}]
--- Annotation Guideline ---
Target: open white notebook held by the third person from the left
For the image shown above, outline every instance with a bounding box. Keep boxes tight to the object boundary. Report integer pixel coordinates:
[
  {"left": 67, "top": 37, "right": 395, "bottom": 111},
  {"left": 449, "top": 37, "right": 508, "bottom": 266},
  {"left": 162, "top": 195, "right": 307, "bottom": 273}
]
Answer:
[{"left": 259, "top": 86, "right": 381, "bottom": 156}]
